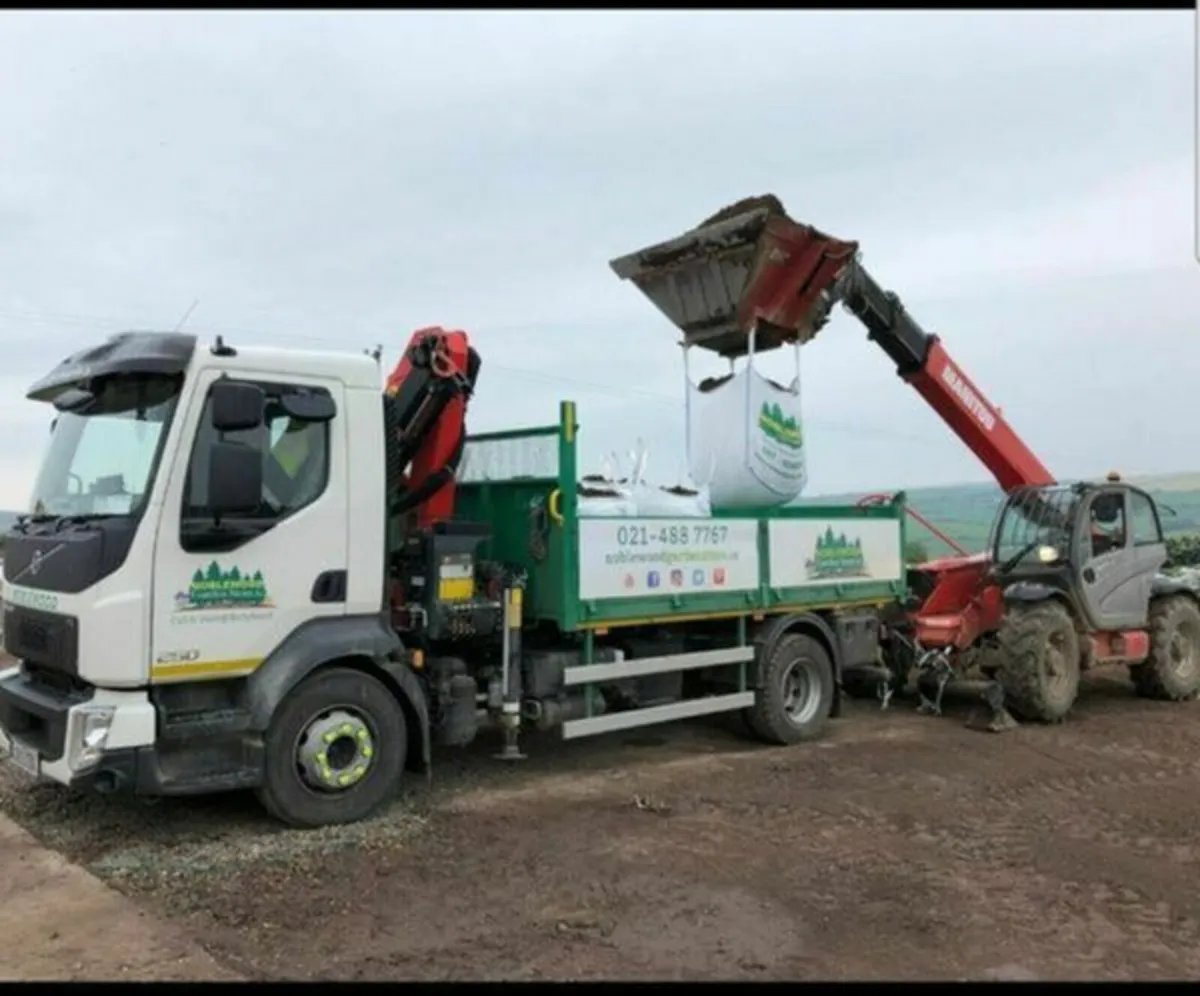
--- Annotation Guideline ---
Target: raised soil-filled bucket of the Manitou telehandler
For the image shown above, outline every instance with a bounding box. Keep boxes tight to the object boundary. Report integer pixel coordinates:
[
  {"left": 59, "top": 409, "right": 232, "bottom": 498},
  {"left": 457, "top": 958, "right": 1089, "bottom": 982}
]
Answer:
[{"left": 608, "top": 194, "right": 858, "bottom": 359}]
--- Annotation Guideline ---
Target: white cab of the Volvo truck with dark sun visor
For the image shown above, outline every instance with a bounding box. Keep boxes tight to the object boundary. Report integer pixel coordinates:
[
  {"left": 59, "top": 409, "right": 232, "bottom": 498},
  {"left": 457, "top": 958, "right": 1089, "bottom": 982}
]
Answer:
[{"left": 0, "top": 334, "right": 397, "bottom": 816}]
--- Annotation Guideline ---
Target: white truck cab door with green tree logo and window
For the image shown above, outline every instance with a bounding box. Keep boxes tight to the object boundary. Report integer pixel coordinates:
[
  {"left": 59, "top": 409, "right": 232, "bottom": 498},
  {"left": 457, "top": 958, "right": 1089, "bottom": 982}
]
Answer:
[{"left": 150, "top": 372, "right": 348, "bottom": 682}]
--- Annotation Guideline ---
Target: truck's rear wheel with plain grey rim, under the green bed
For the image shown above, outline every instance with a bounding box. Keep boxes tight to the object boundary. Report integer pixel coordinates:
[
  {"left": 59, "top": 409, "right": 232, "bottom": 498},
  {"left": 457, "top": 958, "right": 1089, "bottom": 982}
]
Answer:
[{"left": 743, "top": 632, "right": 834, "bottom": 745}]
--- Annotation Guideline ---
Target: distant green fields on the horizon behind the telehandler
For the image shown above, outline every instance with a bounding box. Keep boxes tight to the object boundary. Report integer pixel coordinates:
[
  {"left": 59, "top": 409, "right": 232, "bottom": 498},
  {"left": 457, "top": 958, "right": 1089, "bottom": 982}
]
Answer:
[{"left": 798, "top": 474, "right": 1200, "bottom": 557}]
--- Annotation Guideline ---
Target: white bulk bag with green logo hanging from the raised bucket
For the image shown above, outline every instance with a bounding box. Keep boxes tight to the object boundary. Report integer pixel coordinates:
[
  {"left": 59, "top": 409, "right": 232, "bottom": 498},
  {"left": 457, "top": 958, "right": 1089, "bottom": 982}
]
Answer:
[{"left": 684, "top": 348, "right": 808, "bottom": 509}]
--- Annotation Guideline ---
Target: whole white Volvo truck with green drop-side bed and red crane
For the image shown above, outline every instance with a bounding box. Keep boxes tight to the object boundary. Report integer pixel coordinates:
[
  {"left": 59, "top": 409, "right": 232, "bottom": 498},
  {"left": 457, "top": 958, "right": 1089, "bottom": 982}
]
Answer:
[{"left": 0, "top": 329, "right": 906, "bottom": 826}]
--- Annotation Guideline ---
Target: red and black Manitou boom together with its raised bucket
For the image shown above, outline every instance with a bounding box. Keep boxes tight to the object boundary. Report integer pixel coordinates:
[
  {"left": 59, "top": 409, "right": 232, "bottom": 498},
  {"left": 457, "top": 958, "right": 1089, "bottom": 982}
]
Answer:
[{"left": 610, "top": 194, "right": 1054, "bottom": 493}]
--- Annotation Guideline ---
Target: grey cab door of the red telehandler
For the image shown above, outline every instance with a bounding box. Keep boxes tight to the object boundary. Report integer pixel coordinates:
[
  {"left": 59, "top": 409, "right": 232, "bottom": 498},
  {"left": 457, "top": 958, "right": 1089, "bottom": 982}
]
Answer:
[{"left": 1078, "top": 488, "right": 1166, "bottom": 630}]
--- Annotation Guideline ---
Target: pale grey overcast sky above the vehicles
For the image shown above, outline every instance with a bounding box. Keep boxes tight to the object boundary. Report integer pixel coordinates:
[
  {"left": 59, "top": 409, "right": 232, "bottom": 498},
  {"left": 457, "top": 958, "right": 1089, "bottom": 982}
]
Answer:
[{"left": 0, "top": 11, "right": 1200, "bottom": 508}]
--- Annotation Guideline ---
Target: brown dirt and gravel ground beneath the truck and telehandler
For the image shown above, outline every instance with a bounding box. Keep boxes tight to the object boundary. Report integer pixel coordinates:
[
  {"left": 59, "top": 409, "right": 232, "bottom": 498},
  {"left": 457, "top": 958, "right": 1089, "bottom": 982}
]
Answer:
[{"left": 0, "top": 678, "right": 1200, "bottom": 979}]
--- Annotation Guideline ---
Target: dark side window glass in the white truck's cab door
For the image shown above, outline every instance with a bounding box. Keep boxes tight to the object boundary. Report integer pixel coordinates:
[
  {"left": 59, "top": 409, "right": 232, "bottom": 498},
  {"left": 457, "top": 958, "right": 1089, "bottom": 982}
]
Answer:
[{"left": 180, "top": 383, "right": 329, "bottom": 550}]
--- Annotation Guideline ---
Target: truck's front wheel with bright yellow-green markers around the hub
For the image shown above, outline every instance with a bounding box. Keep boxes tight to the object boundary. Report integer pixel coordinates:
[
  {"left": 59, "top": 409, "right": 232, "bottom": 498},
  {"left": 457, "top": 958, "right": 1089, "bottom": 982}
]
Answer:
[{"left": 258, "top": 667, "right": 408, "bottom": 827}]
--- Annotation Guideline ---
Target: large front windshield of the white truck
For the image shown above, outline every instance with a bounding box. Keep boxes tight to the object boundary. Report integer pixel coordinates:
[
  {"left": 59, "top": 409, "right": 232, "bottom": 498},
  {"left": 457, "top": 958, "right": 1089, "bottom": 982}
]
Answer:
[{"left": 30, "top": 377, "right": 182, "bottom": 516}]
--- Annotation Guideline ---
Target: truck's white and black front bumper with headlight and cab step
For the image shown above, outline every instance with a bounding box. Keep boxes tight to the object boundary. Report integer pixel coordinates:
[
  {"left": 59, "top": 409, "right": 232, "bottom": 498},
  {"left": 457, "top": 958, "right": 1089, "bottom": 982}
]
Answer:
[{"left": 0, "top": 667, "right": 262, "bottom": 796}]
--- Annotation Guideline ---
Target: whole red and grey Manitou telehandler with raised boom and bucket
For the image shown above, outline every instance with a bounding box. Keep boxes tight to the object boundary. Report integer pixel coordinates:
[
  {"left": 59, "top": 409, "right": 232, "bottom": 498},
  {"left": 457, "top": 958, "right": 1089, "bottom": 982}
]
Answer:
[{"left": 611, "top": 194, "right": 1200, "bottom": 731}]
